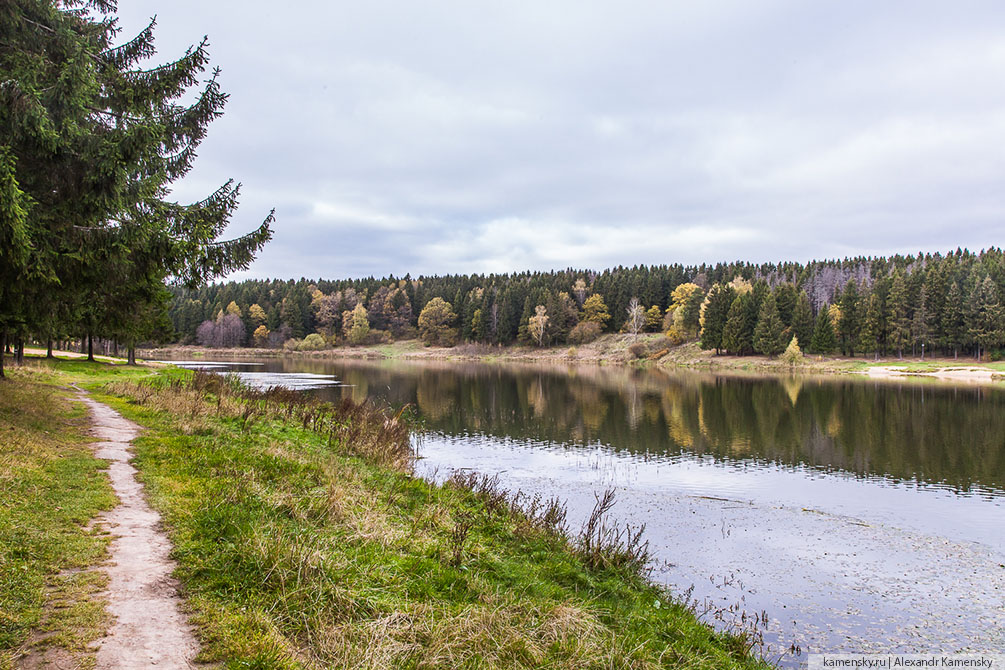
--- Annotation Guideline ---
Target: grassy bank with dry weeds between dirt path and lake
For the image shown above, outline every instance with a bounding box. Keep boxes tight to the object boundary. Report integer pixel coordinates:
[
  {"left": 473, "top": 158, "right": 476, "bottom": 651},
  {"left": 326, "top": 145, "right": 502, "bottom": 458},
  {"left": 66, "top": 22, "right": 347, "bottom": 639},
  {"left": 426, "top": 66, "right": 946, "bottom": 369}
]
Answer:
[{"left": 0, "top": 363, "right": 764, "bottom": 668}]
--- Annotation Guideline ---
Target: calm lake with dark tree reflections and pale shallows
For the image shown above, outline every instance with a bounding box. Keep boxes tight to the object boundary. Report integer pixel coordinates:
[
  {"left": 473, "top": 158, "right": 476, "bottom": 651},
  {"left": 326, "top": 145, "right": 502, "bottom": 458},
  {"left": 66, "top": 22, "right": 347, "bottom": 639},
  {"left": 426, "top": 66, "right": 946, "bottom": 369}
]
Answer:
[{"left": 156, "top": 359, "right": 1005, "bottom": 666}]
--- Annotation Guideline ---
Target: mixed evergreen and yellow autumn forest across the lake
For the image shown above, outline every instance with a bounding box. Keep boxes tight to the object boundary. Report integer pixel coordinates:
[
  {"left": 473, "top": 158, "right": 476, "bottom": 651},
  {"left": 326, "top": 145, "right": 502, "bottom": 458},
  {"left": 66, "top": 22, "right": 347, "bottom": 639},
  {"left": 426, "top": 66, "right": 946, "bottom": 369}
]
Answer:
[{"left": 169, "top": 247, "right": 1005, "bottom": 359}]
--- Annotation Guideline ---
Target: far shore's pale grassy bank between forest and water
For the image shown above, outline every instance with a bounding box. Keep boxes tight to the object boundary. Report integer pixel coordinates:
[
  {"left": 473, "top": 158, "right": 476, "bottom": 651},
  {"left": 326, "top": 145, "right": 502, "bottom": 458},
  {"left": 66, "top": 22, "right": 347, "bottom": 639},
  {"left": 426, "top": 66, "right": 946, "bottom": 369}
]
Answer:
[{"left": 140, "top": 333, "right": 1005, "bottom": 384}]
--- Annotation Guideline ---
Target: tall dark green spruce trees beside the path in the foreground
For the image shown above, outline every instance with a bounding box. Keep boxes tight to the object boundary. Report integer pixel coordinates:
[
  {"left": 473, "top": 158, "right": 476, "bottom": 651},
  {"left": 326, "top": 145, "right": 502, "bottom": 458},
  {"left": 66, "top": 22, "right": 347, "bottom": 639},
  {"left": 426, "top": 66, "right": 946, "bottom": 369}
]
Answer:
[{"left": 0, "top": 0, "right": 272, "bottom": 377}]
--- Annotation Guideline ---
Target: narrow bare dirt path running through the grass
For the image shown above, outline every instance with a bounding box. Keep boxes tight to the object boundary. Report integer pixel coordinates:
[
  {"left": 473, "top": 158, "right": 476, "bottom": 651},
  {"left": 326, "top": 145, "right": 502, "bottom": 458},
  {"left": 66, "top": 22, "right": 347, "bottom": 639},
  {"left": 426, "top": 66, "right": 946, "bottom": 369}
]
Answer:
[{"left": 79, "top": 392, "right": 199, "bottom": 670}]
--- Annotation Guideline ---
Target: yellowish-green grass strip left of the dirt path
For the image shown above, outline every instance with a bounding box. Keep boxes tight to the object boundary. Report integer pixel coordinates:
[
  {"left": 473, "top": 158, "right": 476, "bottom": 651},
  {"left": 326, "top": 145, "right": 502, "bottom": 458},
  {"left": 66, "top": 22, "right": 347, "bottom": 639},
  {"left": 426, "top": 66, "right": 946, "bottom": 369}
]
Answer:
[{"left": 0, "top": 361, "right": 116, "bottom": 668}]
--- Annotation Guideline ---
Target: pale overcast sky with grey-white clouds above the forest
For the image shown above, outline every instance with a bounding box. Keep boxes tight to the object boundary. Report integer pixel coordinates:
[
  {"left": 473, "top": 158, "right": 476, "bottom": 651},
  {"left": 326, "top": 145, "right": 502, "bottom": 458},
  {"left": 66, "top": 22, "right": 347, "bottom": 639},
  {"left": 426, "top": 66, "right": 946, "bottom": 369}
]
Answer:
[{"left": 112, "top": 0, "right": 1005, "bottom": 279}]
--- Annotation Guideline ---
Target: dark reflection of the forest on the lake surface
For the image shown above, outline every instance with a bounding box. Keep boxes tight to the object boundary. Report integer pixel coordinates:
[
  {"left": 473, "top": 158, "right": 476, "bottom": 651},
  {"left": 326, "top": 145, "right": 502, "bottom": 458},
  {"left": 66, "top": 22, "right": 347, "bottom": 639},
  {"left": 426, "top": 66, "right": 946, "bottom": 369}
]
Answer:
[{"left": 245, "top": 361, "right": 1005, "bottom": 495}]
